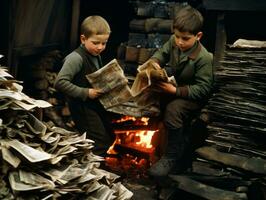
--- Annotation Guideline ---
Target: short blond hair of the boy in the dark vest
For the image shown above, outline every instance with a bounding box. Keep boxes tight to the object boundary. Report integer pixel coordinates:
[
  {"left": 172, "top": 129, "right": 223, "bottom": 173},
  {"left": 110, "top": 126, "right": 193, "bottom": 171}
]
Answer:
[{"left": 80, "top": 15, "right": 111, "bottom": 37}]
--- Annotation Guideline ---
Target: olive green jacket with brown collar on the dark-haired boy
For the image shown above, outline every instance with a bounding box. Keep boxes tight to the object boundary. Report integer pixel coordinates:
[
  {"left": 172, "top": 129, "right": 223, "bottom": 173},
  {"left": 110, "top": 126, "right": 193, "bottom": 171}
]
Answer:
[{"left": 151, "top": 35, "right": 214, "bottom": 101}]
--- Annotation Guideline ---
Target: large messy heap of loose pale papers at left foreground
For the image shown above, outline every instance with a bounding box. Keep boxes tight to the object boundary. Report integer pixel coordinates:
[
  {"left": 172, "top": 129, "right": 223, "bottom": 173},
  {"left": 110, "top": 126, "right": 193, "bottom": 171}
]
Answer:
[{"left": 0, "top": 68, "right": 133, "bottom": 200}]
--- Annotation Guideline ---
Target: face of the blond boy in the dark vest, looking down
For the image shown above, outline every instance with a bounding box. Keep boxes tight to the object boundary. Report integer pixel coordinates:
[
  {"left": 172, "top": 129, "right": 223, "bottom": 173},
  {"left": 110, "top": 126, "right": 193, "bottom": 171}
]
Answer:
[{"left": 80, "top": 34, "right": 110, "bottom": 56}]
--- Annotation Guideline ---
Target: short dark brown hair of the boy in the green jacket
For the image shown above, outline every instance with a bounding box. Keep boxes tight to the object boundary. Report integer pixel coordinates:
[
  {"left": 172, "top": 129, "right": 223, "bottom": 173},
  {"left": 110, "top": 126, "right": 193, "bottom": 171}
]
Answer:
[{"left": 173, "top": 5, "right": 203, "bottom": 35}]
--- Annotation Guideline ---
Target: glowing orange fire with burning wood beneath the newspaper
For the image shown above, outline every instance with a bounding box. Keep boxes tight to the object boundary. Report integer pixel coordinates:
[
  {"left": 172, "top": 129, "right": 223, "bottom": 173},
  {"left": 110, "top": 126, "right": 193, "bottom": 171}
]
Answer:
[{"left": 105, "top": 116, "right": 159, "bottom": 175}]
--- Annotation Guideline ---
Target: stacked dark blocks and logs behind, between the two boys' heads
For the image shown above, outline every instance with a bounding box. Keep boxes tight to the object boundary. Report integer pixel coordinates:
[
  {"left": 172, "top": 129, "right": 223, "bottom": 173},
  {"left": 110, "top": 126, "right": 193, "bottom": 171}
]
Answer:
[{"left": 117, "top": 0, "right": 186, "bottom": 76}]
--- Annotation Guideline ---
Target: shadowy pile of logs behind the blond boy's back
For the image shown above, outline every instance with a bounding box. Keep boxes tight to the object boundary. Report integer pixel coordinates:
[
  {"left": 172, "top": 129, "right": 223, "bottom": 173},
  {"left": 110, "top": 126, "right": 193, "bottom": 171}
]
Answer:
[{"left": 21, "top": 50, "right": 74, "bottom": 129}]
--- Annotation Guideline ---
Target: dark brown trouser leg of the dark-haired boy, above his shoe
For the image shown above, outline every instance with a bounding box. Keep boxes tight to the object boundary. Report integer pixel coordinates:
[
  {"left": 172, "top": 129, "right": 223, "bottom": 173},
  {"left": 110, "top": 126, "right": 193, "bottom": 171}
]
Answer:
[{"left": 163, "top": 98, "right": 202, "bottom": 166}]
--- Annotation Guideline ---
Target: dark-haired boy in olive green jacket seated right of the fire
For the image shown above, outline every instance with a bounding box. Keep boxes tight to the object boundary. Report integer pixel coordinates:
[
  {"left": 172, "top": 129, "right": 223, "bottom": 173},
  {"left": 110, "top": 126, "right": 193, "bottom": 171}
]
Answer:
[{"left": 148, "top": 6, "right": 213, "bottom": 177}]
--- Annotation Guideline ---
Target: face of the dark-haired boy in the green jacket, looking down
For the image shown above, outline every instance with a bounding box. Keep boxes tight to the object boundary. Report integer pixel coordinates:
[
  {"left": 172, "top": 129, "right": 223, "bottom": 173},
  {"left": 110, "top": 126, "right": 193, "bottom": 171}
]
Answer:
[{"left": 174, "top": 30, "right": 202, "bottom": 51}]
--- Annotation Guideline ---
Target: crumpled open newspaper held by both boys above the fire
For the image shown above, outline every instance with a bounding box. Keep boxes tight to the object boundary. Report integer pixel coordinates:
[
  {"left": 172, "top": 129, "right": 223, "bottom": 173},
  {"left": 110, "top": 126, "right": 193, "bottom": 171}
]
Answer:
[{"left": 86, "top": 59, "right": 175, "bottom": 117}]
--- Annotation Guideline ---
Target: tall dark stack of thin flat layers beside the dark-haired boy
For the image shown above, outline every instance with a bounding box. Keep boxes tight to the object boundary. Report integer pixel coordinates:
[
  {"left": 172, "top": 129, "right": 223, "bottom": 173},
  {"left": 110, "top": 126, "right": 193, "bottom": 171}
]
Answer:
[{"left": 167, "top": 41, "right": 266, "bottom": 200}]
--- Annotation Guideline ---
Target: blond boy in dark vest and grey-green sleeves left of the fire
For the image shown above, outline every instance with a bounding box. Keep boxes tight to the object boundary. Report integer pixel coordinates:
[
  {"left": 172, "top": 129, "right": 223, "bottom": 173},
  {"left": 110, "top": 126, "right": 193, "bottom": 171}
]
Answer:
[{"left": 55, "top": 16, "right": 114, "bottom": 156}]
